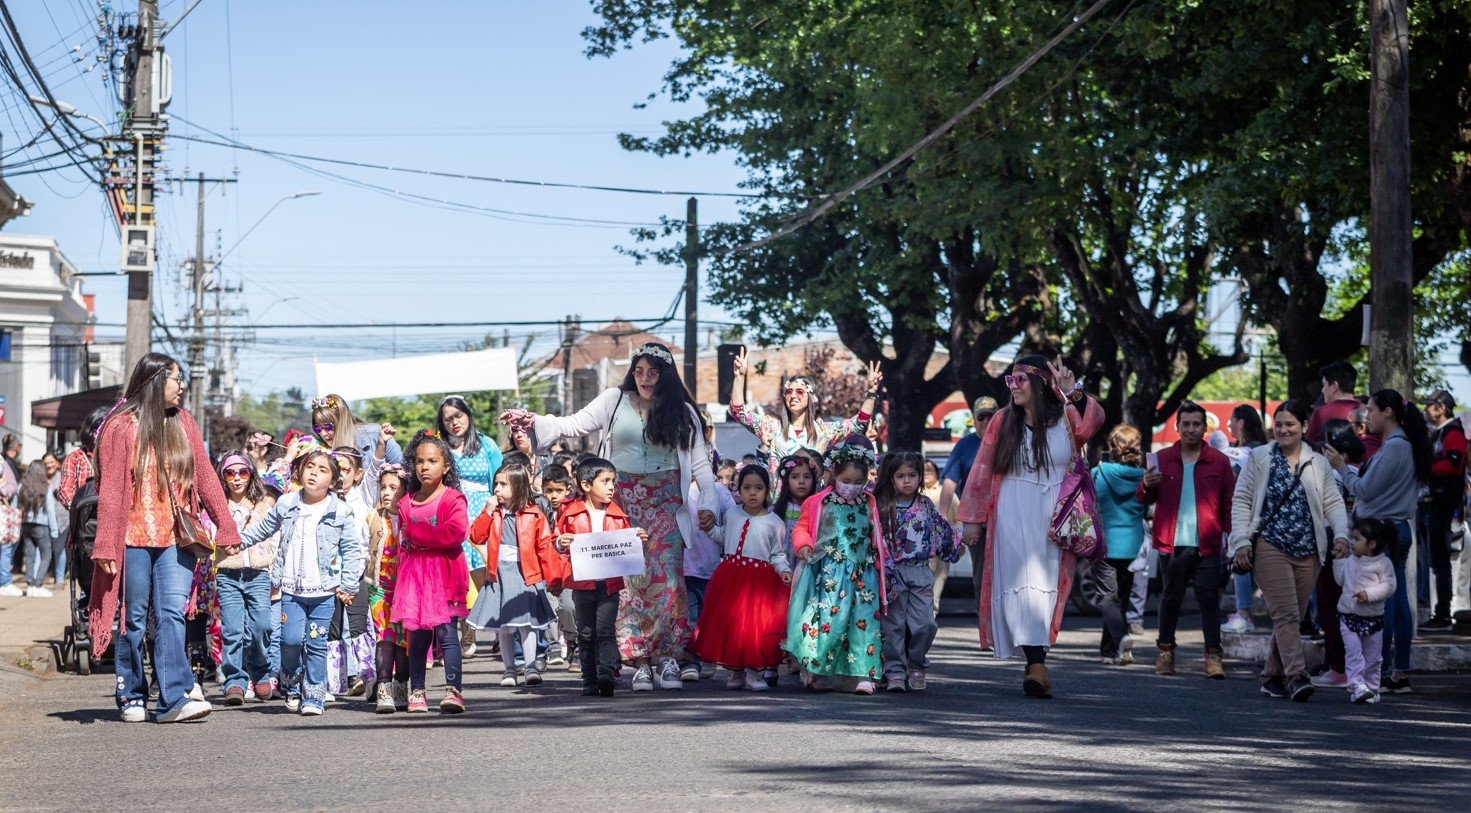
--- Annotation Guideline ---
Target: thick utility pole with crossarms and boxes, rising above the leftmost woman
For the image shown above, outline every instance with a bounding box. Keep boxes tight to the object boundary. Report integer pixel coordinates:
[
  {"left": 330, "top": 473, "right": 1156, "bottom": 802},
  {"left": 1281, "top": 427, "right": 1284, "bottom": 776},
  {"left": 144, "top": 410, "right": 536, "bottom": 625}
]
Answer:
[{"left": 119, "top": 0, "right": 169, "bottom": 375}]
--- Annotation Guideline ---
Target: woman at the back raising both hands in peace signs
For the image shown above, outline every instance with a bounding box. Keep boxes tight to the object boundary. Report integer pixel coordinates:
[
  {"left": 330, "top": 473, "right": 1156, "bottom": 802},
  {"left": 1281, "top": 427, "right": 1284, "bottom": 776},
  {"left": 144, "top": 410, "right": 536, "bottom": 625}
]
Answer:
[{"left": 730, "top": 344, "right": 884, "bottom": 478}]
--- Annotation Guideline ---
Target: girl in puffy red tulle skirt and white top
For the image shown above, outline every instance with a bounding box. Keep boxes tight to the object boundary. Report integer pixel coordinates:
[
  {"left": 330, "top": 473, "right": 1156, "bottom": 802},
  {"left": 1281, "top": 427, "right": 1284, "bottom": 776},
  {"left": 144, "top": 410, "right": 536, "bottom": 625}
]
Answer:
[{"left": 690, "top": 465, "right": 791, "bottom": 691}]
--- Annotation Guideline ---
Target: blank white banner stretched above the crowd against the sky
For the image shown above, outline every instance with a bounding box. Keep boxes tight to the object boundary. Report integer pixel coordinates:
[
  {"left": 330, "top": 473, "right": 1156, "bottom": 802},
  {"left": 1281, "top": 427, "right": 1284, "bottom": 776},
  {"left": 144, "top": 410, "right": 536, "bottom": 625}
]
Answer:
[{"left": 315, "top": 347, "right": 518, "bottom": 399}]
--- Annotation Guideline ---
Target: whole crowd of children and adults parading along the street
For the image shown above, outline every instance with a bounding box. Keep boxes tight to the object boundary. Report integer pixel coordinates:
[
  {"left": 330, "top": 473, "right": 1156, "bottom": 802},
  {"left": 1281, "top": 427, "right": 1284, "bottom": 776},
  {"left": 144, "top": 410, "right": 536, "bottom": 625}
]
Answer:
[{"left": 0, "top": 343, "right": 1467, "bottom": 722}]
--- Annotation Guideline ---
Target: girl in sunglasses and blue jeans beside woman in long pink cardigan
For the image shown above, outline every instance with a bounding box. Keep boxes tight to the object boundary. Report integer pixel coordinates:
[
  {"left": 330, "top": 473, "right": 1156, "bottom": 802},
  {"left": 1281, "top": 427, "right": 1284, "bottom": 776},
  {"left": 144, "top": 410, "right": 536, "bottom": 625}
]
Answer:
[{"left": 215, "top": 448, "right": 277, "bottom": 706}]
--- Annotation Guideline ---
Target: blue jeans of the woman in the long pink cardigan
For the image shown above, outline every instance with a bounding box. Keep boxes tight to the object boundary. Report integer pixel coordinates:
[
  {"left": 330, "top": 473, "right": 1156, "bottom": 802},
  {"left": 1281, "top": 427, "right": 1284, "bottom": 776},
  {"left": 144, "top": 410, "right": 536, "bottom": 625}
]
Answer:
[{"left": 115, "top": 547, "right": 196, "bottom": 714}]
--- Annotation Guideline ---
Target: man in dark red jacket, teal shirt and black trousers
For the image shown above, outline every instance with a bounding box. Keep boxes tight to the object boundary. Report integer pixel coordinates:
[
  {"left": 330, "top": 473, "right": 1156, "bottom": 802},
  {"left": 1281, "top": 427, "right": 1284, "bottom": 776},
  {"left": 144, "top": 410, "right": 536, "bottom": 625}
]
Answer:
[{"left": 1137, "top": 401, "right": 1236, "bottom": 681}]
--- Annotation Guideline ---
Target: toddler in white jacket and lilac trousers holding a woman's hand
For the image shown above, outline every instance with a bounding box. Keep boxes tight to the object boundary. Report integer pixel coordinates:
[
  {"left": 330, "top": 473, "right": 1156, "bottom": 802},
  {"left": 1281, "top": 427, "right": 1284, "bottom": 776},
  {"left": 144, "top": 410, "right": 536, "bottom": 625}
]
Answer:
[{"left": 1333, "top": 519, "right": 1396, "bottom": 703}]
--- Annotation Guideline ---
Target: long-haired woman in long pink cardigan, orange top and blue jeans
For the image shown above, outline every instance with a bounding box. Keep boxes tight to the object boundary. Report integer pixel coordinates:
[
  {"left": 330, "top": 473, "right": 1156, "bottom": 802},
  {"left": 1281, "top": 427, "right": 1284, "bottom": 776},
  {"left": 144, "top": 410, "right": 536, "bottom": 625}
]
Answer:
[{"left": 88, "top": 353, "right": 240, "bottom": 723}]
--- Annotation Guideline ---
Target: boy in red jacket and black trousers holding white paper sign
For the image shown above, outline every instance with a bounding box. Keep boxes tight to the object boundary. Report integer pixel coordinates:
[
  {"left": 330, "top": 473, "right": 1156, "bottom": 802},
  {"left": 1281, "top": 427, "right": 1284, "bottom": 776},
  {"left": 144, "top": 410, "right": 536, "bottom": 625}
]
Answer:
[{"left": 556, "top": 457, "right": 649, "bottom": 697}]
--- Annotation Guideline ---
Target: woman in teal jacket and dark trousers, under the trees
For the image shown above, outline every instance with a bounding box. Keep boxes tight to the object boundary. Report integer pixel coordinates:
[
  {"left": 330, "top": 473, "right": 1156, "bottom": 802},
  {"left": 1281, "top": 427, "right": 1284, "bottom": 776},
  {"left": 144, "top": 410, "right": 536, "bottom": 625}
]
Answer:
[{"left": 1093, "top": 425, "right": 1146, "bottom": 666}]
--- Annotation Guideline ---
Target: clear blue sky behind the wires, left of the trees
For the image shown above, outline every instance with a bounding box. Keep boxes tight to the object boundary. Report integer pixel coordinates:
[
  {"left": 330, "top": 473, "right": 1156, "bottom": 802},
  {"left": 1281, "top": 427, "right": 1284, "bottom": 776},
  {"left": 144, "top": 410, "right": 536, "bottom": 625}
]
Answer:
[{"left": 0, "top": 0, "right": 741, "bottom": 394}]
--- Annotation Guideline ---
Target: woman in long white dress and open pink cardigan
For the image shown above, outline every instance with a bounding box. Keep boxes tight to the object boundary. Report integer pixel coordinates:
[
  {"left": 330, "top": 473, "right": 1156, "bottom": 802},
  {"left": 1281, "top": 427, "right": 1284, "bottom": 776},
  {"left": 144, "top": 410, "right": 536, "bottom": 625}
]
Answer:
[{"left": 959, "top": 356, "right": 1103, "bottom": 697}]
